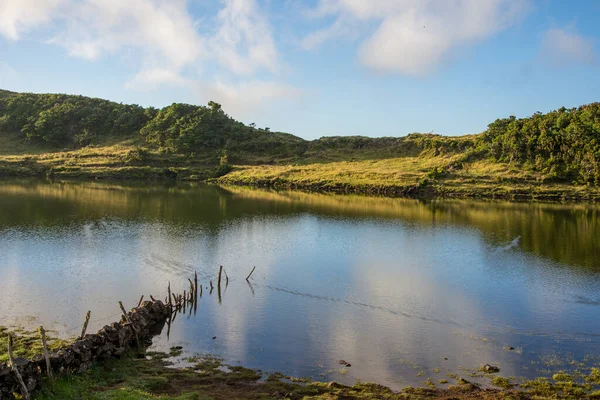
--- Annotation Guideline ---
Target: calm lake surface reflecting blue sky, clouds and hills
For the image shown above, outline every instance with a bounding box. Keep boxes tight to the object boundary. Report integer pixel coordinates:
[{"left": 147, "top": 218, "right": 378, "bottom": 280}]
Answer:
[{"left": 0, "top": 182, "right": 600, "bottom": 388}]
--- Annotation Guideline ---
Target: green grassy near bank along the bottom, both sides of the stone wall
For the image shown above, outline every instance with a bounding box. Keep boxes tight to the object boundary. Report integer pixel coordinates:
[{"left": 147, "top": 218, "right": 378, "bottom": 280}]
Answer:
[{"left": 0, "top": 327, "right": 600, "bottom": 400}]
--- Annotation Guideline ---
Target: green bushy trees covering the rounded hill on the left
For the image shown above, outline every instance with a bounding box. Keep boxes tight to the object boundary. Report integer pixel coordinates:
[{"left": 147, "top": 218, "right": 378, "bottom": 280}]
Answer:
[{"left": 0, "top": 91, "right": 305, "bottom": 156}]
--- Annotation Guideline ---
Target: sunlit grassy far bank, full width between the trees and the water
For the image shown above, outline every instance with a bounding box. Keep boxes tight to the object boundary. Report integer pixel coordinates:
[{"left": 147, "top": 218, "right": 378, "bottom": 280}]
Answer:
[{"left": 0, "top": 144, "right": 600, "bottom": 203}]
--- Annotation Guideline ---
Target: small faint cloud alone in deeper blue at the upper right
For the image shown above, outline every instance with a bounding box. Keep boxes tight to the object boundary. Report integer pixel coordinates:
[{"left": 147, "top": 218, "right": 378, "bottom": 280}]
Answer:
[{"left": 541, "top": 28, "right": 596, "bottom": 67}]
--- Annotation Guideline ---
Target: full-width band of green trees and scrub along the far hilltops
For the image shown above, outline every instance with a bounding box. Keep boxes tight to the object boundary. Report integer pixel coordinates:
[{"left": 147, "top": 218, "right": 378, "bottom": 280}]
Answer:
[{"left": 0, "top": 90, "right": 600, "bottom": 186}]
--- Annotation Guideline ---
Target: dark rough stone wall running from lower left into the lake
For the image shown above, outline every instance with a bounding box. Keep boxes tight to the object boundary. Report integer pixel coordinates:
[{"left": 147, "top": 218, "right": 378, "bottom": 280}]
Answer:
[{"left": 0, "top": 300, "right": 171, "bottom": 400}]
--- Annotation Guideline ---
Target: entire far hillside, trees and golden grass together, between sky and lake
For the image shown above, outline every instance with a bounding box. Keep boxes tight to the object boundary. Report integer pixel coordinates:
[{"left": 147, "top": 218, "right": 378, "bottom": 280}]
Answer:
[{"left": 0, "top": 90, "right": 600, "bottom": 199}]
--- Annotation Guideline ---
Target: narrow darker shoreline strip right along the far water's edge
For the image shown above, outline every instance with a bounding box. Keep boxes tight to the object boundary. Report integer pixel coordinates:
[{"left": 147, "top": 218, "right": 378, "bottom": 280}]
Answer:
[{"left": 0, "top": 167, "right": 600, "bottom": 204}]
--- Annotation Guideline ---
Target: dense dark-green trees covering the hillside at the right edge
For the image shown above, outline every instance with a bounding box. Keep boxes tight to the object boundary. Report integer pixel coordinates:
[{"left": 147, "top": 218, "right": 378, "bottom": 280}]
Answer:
[{"left": 478, "top": 103, "right": 600, "bottom": 186}]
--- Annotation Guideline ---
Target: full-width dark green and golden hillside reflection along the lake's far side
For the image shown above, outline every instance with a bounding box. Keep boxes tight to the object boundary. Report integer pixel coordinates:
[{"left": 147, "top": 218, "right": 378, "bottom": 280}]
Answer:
[{"left": 0, "top": 181, "right": 600, "bottom": 271}]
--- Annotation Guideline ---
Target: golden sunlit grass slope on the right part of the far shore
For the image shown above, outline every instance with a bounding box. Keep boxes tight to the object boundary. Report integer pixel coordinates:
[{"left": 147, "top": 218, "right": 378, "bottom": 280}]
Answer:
[{"left": 216, "top": 154, "right": 600, "bottom": 200}]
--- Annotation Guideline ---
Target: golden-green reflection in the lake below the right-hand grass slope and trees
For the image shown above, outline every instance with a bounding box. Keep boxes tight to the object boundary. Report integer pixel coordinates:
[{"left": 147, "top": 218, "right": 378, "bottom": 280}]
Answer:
[{"left": 220, "top": 187, "right": 600, "bottom": 271}]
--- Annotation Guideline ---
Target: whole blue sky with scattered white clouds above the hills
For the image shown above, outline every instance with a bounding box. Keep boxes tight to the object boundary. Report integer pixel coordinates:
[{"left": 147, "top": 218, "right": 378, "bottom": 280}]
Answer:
[{"left": 0, "top": 0, "right": 600, "bottom": 139}]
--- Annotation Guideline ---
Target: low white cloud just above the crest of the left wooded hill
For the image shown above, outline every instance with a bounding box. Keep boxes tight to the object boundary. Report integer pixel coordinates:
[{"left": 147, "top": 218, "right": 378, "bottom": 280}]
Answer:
[{"left": 196, "top": 80, "right": 301, "bottom": 117}]
